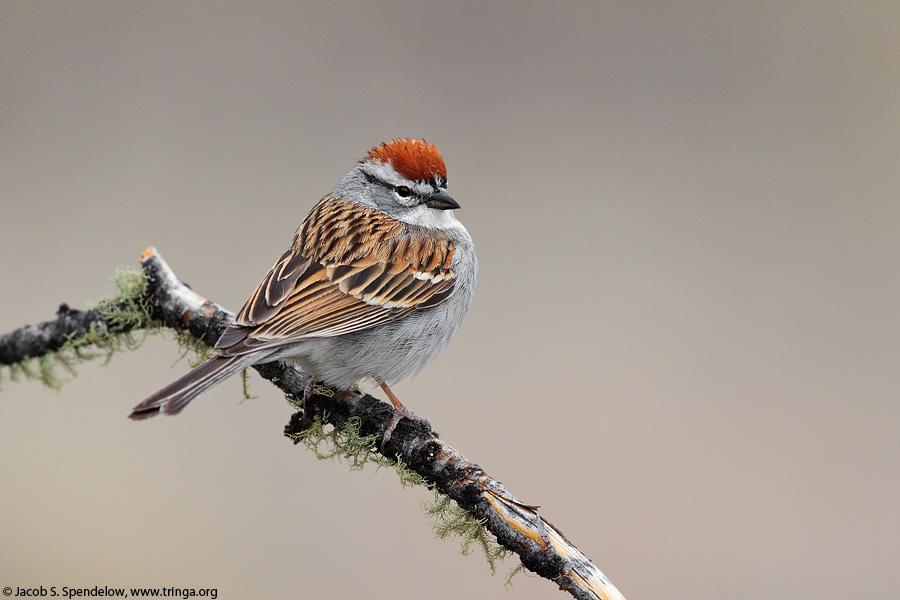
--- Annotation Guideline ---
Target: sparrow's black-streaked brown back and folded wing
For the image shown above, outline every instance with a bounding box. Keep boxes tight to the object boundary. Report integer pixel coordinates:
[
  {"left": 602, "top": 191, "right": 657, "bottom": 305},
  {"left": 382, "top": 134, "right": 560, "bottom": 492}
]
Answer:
[{"left": 216, "top": 196, "right": 455, "bottom": 355}]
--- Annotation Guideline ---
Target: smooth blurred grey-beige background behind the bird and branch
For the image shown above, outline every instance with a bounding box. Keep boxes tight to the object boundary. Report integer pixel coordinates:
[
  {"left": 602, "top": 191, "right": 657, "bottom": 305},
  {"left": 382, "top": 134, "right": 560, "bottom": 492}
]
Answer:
[{"left": 0, "top": 0, "right": 900, "bottom": 600}]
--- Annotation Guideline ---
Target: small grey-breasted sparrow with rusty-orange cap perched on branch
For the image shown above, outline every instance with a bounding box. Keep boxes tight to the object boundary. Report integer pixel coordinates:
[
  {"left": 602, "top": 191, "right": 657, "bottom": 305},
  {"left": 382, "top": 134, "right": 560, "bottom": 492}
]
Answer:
[{"left": 129, "top": 138, "right": 478, "bottom": 448}]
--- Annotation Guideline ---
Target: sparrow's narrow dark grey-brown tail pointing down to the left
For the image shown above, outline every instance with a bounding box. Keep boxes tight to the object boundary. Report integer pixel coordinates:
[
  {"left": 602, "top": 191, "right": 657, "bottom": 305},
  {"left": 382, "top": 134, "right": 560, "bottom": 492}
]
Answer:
[{"left": 128, "top": 355, "right": 255, "bottom": 421}]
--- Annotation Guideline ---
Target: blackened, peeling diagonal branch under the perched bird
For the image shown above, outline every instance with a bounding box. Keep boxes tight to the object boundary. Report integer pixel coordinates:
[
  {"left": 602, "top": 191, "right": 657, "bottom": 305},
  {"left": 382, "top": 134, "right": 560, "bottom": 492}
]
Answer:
[{"left": 0, "top": 247, "right": 624, "bottom": 600}]
